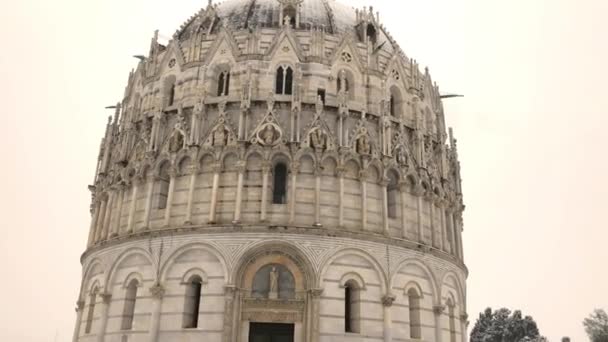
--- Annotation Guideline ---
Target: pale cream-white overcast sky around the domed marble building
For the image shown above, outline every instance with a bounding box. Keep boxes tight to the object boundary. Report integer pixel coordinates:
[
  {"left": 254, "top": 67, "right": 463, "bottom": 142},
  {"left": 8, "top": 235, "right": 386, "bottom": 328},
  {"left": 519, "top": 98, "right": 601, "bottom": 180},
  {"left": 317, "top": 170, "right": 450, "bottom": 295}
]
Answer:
[{"left": 0, "top": 0, "right": 608, "bottom": 342}]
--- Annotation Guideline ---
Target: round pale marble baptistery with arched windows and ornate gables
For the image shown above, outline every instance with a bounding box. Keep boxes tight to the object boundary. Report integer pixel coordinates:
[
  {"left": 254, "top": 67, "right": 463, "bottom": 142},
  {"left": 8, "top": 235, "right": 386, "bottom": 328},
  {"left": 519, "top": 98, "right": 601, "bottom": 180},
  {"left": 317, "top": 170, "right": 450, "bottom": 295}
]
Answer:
[{"left": 73, "top": 0, "right": 468, "bottom": 342}]
